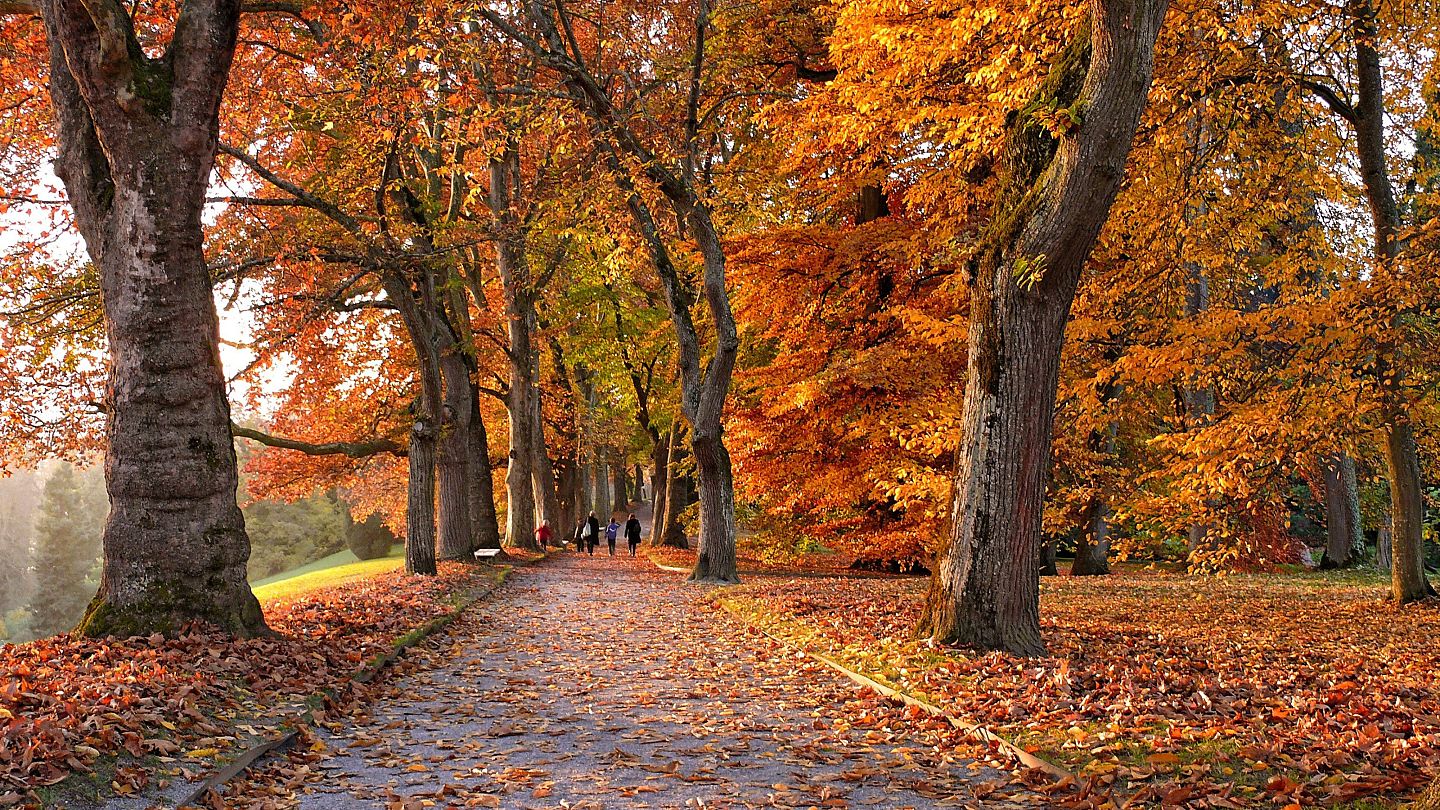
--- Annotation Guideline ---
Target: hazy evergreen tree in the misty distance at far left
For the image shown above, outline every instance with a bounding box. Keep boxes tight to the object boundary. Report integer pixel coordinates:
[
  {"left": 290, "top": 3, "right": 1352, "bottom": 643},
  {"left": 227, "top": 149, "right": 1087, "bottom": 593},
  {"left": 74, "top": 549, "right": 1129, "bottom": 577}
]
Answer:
[{"left": 30, "top": 464, "right": 104, "bottom": 636}]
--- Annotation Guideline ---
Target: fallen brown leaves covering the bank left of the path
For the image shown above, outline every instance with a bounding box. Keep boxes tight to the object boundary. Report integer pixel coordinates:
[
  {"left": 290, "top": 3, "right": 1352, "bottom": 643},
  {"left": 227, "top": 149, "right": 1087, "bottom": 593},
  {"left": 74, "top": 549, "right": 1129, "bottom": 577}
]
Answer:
[{"left": 0, "top": 564, "right": 478, "bottom": 806}]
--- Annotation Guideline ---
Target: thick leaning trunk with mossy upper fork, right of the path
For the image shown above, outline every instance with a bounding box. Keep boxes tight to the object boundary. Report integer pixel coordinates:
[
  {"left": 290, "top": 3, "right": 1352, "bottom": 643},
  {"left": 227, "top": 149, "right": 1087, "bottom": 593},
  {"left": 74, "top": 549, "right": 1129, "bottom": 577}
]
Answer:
[{"left": 919, "top": 0, "right": 1165, "bottom": 654}]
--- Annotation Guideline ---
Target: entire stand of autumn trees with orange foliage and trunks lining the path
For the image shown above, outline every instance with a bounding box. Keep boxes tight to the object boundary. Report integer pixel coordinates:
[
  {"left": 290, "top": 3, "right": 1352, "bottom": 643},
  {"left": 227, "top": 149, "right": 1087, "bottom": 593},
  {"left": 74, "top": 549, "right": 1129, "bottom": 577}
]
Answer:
[{"left": 0, "top": 0, "right": 1437, "bottom": 653}]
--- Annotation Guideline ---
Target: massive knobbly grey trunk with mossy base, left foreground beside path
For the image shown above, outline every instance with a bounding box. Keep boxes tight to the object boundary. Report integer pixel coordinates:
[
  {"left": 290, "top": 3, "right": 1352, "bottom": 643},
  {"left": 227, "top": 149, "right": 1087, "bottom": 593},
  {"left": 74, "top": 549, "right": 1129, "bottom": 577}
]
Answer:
[{"left": 39, "top": 0, "right": 265, "bottom": 636}]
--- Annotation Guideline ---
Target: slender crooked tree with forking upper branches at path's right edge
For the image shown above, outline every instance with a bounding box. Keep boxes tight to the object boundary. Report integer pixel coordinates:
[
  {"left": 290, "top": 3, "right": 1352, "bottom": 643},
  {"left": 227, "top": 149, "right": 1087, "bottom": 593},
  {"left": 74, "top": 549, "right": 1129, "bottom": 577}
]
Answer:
[{"left": 477, "top": 1, "right": 739, "bottom": 582}]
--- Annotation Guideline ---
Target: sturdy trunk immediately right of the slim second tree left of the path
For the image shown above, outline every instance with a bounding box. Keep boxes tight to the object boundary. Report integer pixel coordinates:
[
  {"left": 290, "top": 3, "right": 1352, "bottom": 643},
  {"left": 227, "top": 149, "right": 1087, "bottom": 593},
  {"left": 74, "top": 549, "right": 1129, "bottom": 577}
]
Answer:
[{"left": 436, "top": 344, "right": 475, "bottom": 561}]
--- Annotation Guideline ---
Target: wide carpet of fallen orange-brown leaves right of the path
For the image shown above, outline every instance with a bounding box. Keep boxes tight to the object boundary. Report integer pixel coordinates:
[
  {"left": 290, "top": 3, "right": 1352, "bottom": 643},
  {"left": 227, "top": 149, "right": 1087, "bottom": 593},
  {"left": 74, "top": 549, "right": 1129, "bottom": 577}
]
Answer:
[{"left": 724, "top": 572, "right": 1440, "bottom": 807}]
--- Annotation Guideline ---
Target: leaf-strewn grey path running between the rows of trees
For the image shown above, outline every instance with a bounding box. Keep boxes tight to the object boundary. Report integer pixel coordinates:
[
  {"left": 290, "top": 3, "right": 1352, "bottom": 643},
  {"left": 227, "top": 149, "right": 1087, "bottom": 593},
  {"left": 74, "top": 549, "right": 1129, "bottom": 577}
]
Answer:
[{"left": 259, "top": 546, "right": 1038, "bottom": 810}]
